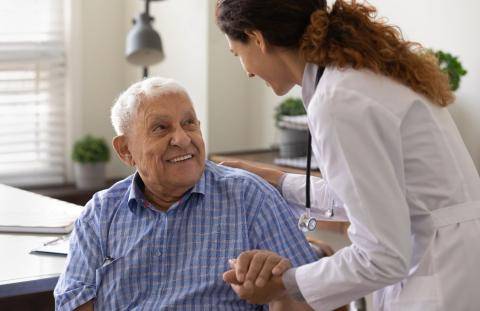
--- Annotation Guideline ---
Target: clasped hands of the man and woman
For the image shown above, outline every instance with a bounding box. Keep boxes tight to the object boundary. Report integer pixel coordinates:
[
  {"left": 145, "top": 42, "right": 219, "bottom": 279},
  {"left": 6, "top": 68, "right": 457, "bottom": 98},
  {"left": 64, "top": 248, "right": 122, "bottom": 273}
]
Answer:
[{"left": 223, "top": 250, "right": 291, "bottom": 304}]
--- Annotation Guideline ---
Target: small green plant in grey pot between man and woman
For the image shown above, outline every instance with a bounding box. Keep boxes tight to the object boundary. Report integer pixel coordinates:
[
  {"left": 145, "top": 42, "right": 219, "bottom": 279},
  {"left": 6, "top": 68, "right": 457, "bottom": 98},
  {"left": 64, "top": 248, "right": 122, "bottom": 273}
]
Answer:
[{"left": 275, "top": 98, "right": 307, "bottom": 158}]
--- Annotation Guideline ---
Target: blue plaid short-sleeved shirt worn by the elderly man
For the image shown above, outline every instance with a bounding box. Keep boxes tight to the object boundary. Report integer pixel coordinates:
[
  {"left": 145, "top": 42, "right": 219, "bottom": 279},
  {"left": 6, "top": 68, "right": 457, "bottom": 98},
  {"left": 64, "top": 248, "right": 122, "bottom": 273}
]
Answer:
[{"left": 54, "top": 161, "right": 316, "bottom": 310}]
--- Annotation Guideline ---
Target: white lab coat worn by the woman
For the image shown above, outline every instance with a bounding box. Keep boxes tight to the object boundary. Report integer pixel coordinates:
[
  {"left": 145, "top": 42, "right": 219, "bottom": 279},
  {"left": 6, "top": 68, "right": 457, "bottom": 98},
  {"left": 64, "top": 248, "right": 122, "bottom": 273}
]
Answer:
[{"left": 282, "top": 64, "right": 480, "bottom": 311}]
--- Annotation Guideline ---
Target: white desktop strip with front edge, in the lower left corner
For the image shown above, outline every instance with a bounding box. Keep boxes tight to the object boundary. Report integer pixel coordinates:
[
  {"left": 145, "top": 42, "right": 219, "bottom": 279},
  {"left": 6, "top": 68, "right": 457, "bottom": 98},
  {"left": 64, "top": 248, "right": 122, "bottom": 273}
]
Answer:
[{"left": 0, "top": 233, "right": 66, "bottom": 298}]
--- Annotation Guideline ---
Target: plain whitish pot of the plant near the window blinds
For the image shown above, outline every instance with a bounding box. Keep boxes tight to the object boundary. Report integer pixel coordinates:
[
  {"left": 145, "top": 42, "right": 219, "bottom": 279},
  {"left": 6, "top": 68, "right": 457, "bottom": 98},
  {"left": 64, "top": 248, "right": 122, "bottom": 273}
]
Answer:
[{"left": 73, "top": 162, "right": 105, "bottom": 189}]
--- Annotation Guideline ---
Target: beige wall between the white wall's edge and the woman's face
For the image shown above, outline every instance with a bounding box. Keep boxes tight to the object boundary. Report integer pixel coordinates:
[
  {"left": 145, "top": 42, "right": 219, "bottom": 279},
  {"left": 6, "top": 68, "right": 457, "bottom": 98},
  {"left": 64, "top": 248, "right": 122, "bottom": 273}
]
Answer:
[{"left": 208, "top": 1, "right": 300, "bottom": 152}]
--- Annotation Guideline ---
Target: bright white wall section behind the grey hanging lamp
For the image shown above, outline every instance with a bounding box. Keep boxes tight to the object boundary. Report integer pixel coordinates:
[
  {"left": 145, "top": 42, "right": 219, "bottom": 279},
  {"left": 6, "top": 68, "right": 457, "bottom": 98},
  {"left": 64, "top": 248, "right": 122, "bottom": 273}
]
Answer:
[{"left": 125, "top": 0, "right": 211, "bottom": 149}]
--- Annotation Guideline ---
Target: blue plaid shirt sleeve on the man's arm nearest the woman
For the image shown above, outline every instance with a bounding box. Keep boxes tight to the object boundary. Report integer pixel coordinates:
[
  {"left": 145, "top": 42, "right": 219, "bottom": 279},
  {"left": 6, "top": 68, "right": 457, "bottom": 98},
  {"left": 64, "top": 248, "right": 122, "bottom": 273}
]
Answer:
[{"left": 249, "top": 186, "right": 318, "bottom": 267}]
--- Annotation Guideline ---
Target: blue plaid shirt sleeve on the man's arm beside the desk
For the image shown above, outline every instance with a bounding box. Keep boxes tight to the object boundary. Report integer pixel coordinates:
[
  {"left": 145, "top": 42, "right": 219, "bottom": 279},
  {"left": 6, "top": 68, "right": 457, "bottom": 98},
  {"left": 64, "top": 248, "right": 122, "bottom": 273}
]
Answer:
[{"left": 54, "top": 199, "right": 102, "bottom": 310}]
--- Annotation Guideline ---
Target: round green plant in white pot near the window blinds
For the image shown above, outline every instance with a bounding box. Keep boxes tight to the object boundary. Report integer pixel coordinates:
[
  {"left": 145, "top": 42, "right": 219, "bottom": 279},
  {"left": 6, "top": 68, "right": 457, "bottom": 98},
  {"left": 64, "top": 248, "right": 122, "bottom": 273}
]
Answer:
[{"left": 72, "top": 135, "right": 110, "bottom": 189}]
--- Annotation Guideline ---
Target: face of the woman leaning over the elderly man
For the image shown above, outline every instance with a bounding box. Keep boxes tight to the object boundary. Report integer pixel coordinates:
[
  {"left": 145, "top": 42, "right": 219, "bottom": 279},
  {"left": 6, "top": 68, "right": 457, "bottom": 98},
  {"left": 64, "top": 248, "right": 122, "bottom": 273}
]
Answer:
[{"left": 226, "top": 35, "right": 295, "bottom": 96}]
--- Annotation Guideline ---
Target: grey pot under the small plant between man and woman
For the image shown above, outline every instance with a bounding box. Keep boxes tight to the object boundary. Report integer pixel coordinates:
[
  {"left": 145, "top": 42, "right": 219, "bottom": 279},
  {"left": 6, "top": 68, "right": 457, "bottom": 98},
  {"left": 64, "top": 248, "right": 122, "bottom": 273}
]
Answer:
[{"left": 279, "top": 128, "right": 308, "bottom": 158}]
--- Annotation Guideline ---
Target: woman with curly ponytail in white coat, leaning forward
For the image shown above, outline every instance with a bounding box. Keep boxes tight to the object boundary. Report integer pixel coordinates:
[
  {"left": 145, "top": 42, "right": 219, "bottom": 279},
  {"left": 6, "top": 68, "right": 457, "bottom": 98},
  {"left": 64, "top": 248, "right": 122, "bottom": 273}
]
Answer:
[{"left": 216, "top": 0, "right": 480, "bottom": 311}]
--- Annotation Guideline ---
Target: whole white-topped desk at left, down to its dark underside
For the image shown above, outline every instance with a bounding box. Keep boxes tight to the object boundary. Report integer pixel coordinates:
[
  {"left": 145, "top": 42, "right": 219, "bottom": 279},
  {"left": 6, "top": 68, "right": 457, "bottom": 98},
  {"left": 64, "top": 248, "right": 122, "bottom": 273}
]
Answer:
[{"left": 0, "top": 185, "right": 81, "bottom": 311}]
